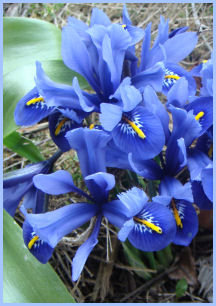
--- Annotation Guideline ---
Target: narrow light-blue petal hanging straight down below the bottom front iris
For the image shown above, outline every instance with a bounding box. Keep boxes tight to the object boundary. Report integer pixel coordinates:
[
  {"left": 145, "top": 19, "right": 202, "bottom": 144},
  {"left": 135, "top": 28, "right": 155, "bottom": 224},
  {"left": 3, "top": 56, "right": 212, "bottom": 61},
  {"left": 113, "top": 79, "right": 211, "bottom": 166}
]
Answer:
[{"left": 72, "top": 216, "right": 101, "bottom": 281}]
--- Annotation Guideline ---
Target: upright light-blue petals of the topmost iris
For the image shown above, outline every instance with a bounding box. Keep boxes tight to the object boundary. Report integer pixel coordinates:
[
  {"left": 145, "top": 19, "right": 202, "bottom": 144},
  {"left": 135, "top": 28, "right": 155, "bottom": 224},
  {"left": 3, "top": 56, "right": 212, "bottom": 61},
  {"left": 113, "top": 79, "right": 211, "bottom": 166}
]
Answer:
[{"left": 62, "top": 5, "right": 144, "bottom": 100}]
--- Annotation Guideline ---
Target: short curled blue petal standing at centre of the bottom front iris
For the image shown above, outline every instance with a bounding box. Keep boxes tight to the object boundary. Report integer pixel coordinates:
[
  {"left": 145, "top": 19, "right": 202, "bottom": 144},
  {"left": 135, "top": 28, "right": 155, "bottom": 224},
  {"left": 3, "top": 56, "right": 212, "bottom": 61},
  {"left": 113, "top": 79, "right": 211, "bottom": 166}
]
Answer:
[{"left": 85, "top": 172, "right": 115, "bottom": 203}]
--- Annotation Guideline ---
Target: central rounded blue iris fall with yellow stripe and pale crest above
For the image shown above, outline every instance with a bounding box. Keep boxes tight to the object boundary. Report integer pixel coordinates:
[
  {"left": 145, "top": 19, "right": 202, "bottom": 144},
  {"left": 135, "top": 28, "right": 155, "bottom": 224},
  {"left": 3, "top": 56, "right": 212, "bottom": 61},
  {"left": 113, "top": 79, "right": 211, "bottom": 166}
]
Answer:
[{"left": 100, "top": 78, "right": 165, "bottom": 159}]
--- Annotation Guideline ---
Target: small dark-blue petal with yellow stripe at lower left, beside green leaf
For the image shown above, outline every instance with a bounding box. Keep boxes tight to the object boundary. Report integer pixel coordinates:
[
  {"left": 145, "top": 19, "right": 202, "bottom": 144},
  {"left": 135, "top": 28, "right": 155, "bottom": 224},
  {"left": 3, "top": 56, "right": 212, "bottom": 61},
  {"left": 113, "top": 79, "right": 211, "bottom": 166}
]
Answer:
[{"left": 23, "top": 221, "right": 54, "bottom": 264}]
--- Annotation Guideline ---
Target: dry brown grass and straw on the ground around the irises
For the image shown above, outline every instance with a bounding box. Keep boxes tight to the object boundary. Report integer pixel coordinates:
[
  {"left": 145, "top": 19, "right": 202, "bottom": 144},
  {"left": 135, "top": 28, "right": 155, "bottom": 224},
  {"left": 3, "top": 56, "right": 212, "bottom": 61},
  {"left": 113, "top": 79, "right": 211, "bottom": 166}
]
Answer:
[{"left": 4, "top": 3, "right": 213, "bottom": 303}]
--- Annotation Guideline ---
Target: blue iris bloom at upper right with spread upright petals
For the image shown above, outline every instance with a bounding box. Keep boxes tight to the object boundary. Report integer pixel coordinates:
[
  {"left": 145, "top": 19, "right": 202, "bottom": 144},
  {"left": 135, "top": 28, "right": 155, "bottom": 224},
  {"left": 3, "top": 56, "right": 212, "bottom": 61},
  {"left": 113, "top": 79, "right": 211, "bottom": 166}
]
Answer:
[{"left": 139, "top": 16, "right": 198, "bottom": 95}]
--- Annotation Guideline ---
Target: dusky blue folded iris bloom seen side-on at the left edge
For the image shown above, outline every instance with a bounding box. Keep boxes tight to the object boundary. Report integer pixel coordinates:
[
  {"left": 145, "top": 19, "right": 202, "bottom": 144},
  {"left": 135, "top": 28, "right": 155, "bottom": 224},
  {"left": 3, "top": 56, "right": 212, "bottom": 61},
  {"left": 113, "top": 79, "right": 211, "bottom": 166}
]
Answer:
[{"left": 3, "top": 152, "right": 62, "bottom": 217}]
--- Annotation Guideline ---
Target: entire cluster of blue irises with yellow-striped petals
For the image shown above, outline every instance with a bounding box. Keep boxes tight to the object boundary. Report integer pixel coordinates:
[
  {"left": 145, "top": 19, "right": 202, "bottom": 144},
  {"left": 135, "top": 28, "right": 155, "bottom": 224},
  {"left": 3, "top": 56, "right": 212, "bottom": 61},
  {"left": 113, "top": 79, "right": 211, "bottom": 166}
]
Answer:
[{"left": 4, "top": 7, "right": 213, "bottom": 281}]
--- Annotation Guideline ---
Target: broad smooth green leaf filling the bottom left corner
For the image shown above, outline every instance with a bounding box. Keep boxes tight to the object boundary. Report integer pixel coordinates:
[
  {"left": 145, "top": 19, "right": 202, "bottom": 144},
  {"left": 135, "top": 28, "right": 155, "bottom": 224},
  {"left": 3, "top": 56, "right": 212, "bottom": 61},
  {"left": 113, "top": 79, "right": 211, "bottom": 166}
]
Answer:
[{"left": 3, "top": 211, "right": 75, "bottom": 303}]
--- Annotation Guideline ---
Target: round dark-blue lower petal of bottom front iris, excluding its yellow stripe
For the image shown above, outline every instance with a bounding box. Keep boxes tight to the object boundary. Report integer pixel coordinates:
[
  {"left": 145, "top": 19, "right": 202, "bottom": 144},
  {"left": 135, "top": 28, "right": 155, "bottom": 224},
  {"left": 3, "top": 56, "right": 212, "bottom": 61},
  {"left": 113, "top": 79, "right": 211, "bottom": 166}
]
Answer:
[{"left": 128, "top": 202, "right": 176, "bottom": 252}]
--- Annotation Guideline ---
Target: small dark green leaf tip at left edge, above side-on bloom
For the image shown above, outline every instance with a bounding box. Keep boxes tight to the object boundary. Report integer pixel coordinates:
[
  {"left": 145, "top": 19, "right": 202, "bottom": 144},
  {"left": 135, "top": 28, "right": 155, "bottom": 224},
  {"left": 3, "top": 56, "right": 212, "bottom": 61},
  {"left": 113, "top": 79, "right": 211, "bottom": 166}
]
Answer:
[{"left": 3, "top": 132, "right": 44, "bottom": 162}]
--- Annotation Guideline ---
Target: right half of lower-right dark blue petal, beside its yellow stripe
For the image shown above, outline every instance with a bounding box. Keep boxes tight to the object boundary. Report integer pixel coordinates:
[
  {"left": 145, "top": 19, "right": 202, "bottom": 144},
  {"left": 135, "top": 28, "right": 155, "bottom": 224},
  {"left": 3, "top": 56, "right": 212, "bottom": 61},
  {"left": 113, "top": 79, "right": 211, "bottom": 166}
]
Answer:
[{"left": 173, "top": 201, "right": 198, "bottom": 246}]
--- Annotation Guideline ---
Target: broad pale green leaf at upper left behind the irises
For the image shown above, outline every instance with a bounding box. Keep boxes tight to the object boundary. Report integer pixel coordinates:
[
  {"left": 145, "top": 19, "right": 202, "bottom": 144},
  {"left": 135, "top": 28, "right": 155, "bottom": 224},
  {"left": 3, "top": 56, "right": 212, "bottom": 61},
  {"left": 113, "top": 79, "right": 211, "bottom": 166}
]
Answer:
[{"left": 3, "top": 17, "right": 89, "bottom": 137}]
